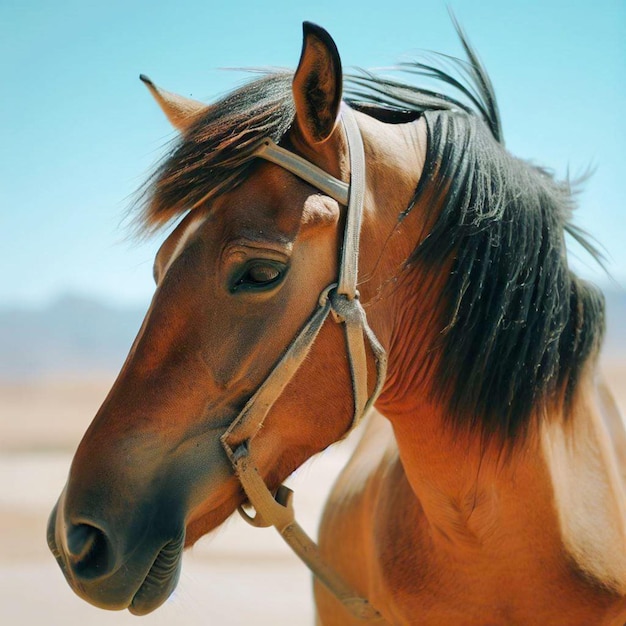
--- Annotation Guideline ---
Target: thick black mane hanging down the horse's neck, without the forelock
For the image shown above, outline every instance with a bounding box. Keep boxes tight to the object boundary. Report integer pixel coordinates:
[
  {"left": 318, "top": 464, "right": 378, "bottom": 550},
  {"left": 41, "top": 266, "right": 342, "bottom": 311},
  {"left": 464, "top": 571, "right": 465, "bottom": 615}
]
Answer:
[{"left": 410, "top": 112, "right": 604, "bottom": 441}]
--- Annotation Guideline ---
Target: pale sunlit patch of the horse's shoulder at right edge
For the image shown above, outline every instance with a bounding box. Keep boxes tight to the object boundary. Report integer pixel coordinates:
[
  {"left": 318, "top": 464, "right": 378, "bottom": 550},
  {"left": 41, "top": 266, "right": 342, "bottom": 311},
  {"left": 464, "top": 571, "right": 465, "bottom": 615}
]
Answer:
[{"left": 543, "top": 372, "right": 626, "bottom": 610}]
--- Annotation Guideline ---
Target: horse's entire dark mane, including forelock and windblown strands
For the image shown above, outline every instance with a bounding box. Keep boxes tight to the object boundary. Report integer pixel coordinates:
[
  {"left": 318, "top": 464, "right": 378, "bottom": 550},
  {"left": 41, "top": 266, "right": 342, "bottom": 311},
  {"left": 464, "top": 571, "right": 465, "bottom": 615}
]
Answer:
[{"left": 138, "top": 26, "right": 604, "bottom": 443}]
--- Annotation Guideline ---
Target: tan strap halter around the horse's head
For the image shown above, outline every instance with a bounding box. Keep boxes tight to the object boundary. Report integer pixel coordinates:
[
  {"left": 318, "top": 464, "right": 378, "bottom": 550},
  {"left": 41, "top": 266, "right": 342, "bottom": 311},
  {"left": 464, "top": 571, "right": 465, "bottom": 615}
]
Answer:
[{"left": 221, "top": 105, "right": 387, "bottom": 620}]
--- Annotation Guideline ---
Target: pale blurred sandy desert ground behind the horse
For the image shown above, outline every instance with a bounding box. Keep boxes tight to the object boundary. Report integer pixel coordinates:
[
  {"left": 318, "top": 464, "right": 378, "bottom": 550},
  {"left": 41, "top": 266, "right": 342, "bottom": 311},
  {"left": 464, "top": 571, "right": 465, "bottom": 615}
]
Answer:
[{"left": 0, "top": 361, "right": 626, "bottom": 626}]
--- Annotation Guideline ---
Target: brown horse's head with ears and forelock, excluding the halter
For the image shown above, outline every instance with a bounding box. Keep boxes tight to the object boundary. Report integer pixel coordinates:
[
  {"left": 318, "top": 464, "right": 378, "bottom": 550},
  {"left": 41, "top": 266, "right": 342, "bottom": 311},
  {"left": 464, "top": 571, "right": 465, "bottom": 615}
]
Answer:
[{"left": 48, "top": 24, "right": 418, "bottom": 614}]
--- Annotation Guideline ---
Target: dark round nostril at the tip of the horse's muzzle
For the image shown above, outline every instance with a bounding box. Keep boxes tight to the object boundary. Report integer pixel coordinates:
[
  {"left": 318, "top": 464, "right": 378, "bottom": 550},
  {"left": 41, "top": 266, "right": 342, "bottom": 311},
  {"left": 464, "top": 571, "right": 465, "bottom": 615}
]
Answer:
[{"left": 67, "top": 524, "right": 114, "bottom": 580}]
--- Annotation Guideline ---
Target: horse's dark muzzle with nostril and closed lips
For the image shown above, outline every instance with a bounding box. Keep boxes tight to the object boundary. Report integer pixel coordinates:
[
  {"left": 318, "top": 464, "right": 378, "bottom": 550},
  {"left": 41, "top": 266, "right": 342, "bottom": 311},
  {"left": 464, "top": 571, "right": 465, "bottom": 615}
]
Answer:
[{"left": 47, "top": 491, "right": 185, "bottom": 615}]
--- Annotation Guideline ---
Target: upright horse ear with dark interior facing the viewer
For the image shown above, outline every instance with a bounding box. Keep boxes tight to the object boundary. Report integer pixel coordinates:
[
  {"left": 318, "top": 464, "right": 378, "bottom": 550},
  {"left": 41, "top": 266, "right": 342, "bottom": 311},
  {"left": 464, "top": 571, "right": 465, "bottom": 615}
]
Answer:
[{"left": 293, "top": 22, "right": 342, "bottom": 143}]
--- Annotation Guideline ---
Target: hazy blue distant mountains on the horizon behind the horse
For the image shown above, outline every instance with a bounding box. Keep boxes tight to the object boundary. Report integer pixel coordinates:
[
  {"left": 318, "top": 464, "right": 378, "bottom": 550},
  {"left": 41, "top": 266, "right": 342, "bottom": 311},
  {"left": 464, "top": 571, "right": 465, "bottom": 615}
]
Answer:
[{"left": 0, "top": 291, "right": 626, "bottom": 380}]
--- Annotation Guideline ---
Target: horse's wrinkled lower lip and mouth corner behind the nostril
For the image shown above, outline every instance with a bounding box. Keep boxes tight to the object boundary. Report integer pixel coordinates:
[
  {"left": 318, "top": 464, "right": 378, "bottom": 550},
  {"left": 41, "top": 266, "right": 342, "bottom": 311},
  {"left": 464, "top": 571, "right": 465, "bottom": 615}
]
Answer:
[{"left": 128, "top": 533, "right": 185, "bottom": 615}]
